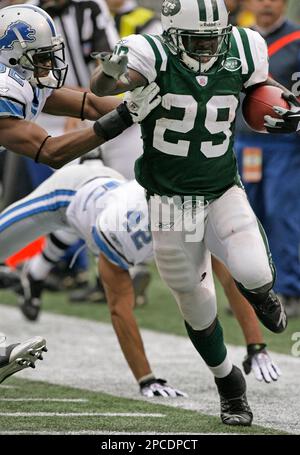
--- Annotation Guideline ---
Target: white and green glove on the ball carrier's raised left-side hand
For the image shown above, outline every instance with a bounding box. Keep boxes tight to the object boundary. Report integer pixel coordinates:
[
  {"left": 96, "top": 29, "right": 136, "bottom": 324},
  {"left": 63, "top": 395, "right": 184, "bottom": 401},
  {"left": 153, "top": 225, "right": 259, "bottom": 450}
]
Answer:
[{"left": 92, "top": 42, "right": 129, "bottom": 84}]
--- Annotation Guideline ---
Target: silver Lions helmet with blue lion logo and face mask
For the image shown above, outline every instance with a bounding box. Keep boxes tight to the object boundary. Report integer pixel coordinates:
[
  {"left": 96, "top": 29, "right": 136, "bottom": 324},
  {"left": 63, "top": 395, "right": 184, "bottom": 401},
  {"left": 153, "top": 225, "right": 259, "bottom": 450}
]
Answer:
[{"left": 0, "top": 4, "right": 68, "bottom": 89}]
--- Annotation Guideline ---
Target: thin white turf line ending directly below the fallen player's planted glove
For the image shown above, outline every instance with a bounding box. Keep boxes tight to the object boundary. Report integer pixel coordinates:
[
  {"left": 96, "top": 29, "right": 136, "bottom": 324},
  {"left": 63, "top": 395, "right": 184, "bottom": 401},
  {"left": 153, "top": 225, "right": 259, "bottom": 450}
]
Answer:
[{"left": 0, "top": 412, "right": 166, "bottom": 418}]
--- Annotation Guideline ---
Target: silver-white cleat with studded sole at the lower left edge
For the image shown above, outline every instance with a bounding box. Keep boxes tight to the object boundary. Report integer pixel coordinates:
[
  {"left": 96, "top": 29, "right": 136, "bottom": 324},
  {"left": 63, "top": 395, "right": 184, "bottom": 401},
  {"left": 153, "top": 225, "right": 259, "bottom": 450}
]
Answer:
[{"left": 0, "top": 337, "right": 48, "bottom": 383}]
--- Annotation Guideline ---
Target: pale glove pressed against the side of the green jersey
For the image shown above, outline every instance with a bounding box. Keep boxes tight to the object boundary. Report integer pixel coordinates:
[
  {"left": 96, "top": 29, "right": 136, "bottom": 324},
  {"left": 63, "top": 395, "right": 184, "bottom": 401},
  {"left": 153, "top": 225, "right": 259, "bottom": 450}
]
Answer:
[{"left": 124, "top": 82, "right": 161, "bottom": 123}]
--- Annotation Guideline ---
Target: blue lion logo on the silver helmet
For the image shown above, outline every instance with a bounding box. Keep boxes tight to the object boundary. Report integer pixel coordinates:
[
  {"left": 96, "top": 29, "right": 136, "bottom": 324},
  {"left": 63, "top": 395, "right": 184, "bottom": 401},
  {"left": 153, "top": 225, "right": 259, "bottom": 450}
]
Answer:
[{"left": 0, "top": 21, "right": 36, "bottom": 51}]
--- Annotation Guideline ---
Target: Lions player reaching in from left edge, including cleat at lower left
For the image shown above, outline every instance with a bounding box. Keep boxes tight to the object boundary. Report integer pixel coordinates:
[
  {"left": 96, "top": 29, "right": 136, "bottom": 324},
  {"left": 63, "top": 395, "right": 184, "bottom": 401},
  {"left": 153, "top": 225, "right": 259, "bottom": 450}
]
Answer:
[{"left": 0, "top": 1, "right": 160, "bottom": 382}]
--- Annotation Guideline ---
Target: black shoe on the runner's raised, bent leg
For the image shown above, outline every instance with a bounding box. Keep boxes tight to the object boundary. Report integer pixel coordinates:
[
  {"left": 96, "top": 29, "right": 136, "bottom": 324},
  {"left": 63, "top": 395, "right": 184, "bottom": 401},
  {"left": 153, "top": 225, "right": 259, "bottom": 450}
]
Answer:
[{"left": 251, "top": 290, "right": 287, "bottom": 333}]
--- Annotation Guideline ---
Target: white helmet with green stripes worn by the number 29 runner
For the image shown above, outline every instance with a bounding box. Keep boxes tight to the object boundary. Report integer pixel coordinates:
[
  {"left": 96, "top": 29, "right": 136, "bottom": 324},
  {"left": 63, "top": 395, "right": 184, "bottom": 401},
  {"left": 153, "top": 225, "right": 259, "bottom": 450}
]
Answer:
[{"left": 161, "top": 0, "right": 232, "bottom": 74}]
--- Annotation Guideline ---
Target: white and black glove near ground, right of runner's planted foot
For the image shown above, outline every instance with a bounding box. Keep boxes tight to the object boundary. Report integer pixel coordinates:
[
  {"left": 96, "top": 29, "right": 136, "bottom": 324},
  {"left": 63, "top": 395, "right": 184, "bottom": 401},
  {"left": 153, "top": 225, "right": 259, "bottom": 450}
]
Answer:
[{"left": 243, "top": 344, "right": 281, "bottom": 384}]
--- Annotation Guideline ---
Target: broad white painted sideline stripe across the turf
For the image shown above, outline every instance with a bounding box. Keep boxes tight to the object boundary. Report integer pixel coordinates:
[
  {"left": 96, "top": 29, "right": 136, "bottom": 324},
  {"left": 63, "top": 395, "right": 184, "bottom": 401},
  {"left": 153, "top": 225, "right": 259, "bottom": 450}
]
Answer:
[{"left": 0, "top": 305, "right": 300, "bottom": 434}]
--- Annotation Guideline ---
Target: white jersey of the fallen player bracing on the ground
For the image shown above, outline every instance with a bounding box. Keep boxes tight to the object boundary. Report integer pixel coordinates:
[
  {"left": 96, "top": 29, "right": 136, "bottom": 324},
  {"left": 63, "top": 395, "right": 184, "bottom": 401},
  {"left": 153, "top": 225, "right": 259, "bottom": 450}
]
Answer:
[{"left": 67, "top": 177, "right": 153, "bottom": 269}]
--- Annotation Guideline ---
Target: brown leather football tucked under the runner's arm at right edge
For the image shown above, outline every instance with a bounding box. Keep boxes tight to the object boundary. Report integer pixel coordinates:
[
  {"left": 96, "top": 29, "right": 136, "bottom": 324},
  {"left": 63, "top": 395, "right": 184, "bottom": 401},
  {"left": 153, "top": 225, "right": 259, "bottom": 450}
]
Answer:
[{"left": 242, "top": 85, "right": 290, "bottom": 133}]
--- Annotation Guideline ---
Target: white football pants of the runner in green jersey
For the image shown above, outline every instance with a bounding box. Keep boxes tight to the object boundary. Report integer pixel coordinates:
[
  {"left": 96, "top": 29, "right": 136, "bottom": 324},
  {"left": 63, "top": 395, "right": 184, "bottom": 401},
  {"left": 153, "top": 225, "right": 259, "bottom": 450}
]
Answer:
[{"left": 150, "top": 186, "right": 273, "bottom": 330}]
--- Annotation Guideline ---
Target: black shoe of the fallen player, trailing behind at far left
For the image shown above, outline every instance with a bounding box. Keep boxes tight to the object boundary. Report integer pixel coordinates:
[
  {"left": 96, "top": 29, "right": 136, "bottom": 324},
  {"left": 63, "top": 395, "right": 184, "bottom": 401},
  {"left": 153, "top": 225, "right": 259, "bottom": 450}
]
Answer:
[{"left": 18, "top": 271, "right": 44, "bottom": 321}]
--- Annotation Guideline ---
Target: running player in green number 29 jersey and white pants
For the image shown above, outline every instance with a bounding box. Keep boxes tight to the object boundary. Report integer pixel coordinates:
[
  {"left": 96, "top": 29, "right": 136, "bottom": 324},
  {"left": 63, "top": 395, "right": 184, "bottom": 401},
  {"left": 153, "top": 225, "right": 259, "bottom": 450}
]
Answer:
[{"left": 91, "top": 0, "right": 300, "bottom": 425}]
